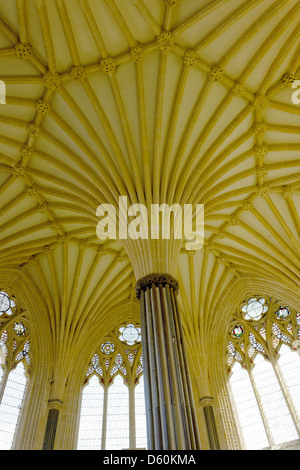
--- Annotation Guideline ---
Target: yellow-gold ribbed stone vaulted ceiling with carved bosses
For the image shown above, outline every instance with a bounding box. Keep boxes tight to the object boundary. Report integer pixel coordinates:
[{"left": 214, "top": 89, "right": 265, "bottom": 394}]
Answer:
[{"left": 0, "top": 0, "right": 300, "bottom": 360}]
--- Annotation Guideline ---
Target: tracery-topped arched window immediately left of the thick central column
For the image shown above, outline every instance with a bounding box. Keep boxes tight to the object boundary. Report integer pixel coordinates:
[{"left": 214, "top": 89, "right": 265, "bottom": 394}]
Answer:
[{"left": 77, "top": 323, "right": 147, "bottom": 450}]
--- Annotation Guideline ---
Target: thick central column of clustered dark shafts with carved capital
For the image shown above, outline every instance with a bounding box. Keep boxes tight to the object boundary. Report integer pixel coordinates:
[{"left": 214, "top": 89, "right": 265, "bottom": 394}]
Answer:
[{"left": 137, "top": 274, "right": 200, "bottom": 450}]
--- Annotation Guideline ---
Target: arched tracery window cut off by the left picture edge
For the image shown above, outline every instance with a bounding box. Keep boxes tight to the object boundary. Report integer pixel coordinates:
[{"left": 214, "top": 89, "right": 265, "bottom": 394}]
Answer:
[{"left": 0, "top": 290, "right": 31, "bottom": 450}]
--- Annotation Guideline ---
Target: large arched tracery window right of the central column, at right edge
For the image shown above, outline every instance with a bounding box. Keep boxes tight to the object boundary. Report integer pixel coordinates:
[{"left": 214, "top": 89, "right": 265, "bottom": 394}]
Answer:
[{"left": 226, "top": 295, "right": 300, "bottom": 450}]
